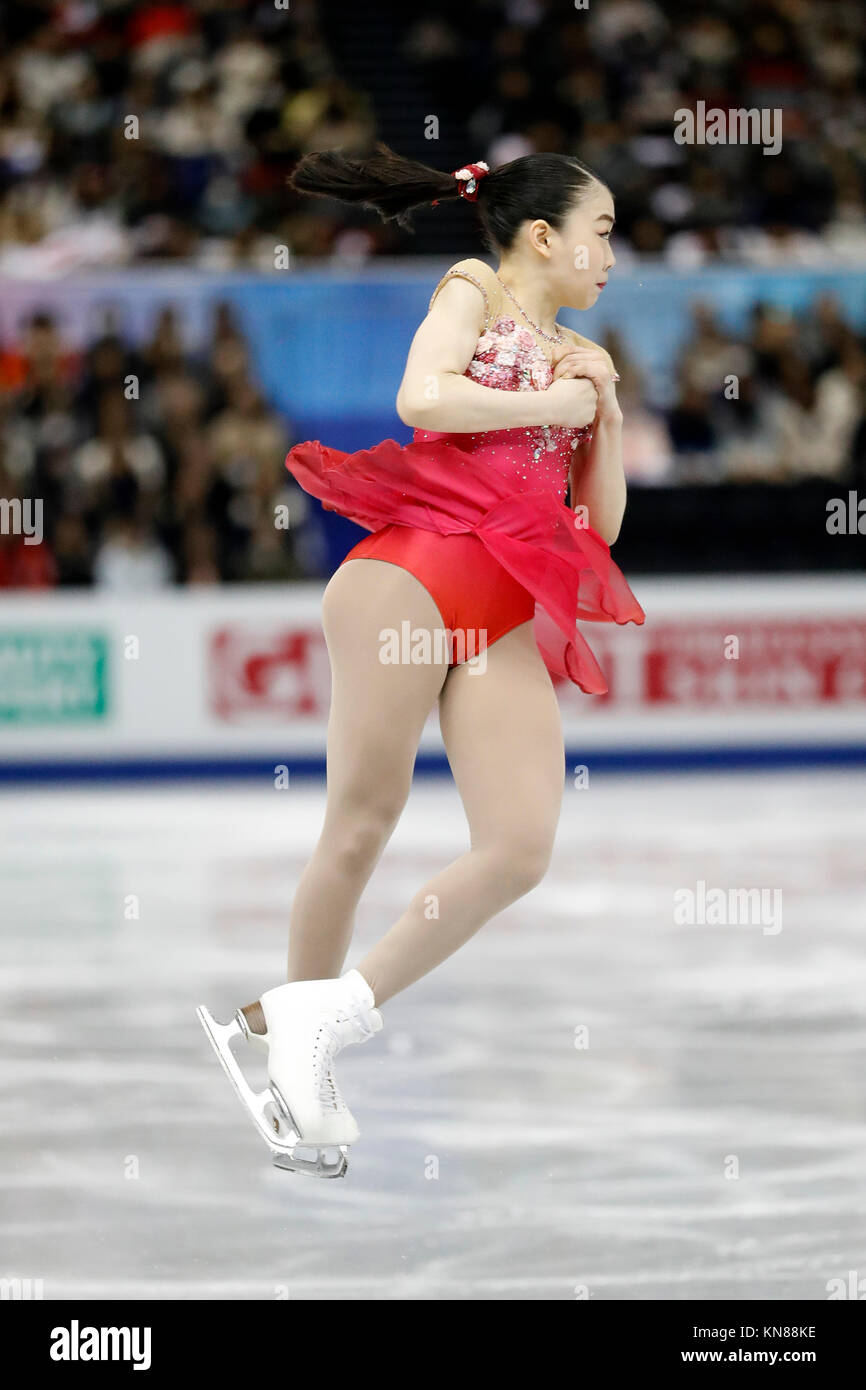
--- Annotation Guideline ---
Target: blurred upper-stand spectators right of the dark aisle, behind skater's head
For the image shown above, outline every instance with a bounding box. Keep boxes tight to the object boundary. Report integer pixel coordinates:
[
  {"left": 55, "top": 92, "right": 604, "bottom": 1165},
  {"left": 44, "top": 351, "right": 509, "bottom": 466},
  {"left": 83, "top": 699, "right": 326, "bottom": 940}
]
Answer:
[{"left": 458, "top": 0, "right": 866, "bottom": 268}]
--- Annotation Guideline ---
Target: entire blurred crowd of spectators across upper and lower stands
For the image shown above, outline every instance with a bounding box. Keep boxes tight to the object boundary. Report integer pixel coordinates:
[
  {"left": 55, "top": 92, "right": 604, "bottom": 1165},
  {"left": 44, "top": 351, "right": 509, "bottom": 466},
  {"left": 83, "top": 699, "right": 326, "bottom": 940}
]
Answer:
[{"left": 0, "top": 0, "right": 866, "bottom": 591}]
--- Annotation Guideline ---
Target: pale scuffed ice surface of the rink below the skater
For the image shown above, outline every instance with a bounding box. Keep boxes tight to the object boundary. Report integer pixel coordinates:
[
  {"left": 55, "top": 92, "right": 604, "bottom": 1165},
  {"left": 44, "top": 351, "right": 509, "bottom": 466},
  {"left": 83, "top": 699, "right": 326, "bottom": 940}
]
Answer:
[{"left": 0, "top": 770, "right": 866, "bottom": 1300}]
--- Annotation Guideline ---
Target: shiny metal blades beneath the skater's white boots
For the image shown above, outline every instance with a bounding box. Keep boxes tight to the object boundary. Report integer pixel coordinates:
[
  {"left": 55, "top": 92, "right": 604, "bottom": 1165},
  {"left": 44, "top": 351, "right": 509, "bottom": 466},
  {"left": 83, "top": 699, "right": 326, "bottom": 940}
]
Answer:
[{"left": 196, "top": 1004, "right": 349, "bottom": 1177}]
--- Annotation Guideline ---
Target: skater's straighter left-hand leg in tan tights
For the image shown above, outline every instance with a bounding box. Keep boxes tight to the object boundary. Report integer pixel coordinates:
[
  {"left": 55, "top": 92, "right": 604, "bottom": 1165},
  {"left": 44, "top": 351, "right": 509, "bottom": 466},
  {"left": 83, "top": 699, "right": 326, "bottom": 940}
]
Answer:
[{"left": 243, "top": 559, "right": 448, "bottom": 1033}]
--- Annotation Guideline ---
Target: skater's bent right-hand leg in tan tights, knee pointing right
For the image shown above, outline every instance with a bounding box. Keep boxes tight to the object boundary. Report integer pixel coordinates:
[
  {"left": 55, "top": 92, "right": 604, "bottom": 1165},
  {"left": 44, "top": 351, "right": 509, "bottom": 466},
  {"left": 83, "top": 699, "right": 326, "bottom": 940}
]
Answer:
[{"left": 357, "top": 623, "right": 564, "bottom": 1005}]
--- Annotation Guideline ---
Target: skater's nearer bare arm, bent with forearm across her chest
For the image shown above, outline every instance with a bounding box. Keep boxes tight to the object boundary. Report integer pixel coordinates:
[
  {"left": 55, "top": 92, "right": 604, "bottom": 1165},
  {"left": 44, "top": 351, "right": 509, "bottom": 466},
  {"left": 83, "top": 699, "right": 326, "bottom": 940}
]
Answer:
[{"left": 396, "top": 277, "right": 596, "bottom": 434}]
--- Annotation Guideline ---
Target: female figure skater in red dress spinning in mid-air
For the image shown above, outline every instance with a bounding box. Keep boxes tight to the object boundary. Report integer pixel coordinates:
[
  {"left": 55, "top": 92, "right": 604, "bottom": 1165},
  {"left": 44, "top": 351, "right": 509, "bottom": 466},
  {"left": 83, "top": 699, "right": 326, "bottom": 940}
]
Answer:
[{"left": 199, "top": 143, "right": 645, "bottom": 1176}]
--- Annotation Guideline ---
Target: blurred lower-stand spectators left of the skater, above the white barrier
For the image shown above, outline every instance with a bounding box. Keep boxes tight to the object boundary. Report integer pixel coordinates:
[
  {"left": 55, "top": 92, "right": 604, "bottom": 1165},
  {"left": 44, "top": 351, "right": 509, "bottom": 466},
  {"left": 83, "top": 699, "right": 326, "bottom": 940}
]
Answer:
[{"left": 0, "top": 304, "right": 309, "bottom": 592}]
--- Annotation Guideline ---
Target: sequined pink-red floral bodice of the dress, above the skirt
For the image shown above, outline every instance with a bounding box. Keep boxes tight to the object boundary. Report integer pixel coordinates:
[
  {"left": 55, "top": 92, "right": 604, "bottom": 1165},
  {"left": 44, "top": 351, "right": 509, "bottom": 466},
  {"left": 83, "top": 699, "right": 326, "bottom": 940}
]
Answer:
[{"left": 413, "top": 314, "right": 592, "bottom": 499}]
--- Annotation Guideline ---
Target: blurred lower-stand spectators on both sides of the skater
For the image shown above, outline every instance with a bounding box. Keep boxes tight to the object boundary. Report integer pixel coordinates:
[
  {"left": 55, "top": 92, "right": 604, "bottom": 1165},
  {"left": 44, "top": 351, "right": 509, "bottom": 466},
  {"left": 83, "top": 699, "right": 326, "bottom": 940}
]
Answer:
[{"left": 0, "top": 287, "right": 866, "bottom": 592}]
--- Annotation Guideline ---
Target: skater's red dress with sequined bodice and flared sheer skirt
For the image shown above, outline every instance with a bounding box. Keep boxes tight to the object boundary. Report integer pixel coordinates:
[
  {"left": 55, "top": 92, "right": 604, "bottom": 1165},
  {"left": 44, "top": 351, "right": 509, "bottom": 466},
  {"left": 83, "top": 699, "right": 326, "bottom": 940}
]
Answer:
[{"left": 286, "top": 259, "right": 645, "bottom": 695}]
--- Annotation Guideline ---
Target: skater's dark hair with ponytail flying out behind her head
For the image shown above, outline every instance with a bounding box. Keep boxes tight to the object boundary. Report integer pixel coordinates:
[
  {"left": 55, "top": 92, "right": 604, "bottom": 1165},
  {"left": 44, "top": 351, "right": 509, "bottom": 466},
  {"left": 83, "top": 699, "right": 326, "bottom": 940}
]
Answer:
[{"left": 288, "top": 140, "right": 601, "bottom": 252}]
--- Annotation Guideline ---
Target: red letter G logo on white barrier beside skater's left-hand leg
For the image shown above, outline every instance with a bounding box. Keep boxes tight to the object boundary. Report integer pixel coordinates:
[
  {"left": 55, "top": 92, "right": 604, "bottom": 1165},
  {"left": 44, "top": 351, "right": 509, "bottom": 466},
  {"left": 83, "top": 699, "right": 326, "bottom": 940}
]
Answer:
[{"left": 209, "top": 624, "right": 329, "bottom": 723}]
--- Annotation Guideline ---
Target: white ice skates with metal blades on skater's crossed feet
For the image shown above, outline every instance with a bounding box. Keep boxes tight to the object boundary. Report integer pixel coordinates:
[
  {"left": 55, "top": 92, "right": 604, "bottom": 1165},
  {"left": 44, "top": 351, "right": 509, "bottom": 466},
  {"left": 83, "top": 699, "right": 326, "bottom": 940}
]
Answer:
[{"left": 196, "top": 970, "right": 382, "bottom": 1177}]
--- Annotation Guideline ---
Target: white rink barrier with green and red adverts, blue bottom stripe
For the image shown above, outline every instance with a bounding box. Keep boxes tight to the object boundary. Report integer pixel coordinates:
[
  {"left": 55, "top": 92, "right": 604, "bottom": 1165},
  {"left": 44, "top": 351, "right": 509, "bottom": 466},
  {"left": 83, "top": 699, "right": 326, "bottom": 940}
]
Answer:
[{"left": 0, "top": 574, "right": 866, "bottom": 781}]
